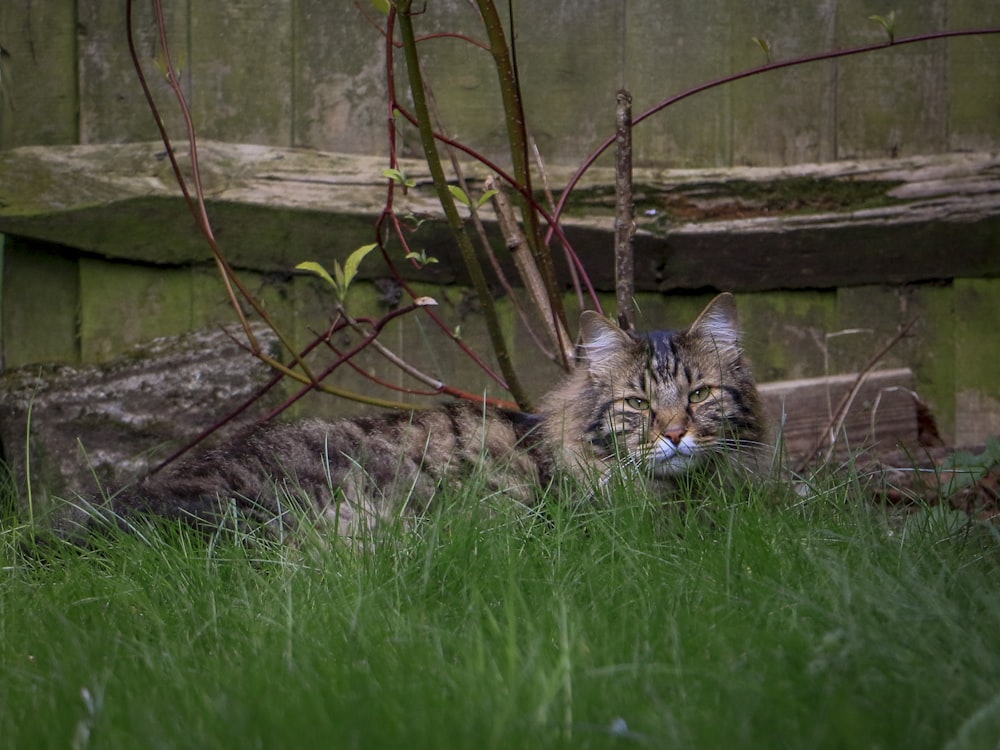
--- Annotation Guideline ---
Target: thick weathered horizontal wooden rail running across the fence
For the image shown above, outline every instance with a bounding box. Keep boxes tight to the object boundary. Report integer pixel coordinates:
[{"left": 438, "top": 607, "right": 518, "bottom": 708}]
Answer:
[{"left": 0, "top": 141, "right": 1000, "bottom": 292}]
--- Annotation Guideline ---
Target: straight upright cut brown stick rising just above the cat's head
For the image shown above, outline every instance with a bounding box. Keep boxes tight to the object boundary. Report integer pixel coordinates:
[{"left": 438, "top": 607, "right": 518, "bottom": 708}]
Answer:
[{"left": 615, "top": 89, "right": 636, "bottom": 331}]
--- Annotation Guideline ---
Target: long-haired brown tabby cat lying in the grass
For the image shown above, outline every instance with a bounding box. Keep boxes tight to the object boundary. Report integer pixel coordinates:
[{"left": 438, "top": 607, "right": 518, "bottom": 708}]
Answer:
[{"left": 92, "top": 294, "right": 763, "bottom": 536}]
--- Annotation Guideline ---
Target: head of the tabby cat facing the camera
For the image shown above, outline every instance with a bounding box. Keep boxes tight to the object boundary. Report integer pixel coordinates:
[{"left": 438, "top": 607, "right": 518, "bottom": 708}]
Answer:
[{"left": 565, "top": 294, "right": 762, "bottom": 476}]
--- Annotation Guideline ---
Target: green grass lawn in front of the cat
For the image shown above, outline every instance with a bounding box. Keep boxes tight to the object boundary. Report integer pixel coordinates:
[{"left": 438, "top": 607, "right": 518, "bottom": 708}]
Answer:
[{"left": 0, "top": 487, "right": 1000, "bottom": 748}]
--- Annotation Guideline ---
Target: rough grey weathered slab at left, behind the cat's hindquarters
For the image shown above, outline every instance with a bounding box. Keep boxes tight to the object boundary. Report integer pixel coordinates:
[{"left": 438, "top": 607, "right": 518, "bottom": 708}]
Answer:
[{"left": 0, "top": 329, "right": 276, "bottom": 512}]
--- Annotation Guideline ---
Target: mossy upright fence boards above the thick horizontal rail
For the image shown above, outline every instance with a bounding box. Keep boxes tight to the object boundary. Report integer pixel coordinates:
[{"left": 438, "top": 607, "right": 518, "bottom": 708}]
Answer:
[{"left": 0, "top": 0, "right": 1000, "bottom": 167}]
